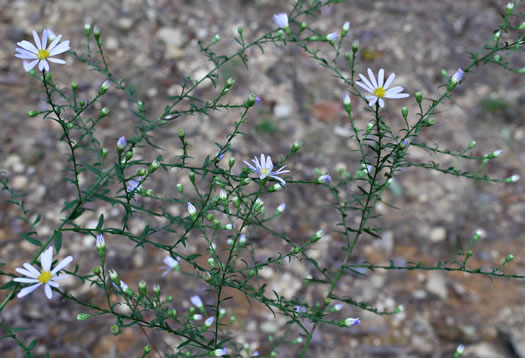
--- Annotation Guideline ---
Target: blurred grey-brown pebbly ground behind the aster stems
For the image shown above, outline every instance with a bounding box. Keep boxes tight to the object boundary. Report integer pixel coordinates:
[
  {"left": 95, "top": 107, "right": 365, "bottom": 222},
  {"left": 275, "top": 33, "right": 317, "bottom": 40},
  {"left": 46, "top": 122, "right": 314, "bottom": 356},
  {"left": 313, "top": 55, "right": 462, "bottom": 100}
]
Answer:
[{"left": 0, "top": 0, "right": 525, "bottom": 357}]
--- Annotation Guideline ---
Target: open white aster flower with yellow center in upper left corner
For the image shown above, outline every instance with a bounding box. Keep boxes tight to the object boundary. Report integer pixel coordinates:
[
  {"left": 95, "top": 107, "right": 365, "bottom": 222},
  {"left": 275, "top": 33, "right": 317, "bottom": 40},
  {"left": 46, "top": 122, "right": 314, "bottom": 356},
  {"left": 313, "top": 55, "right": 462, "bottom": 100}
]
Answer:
[{"left": 15, "top": 29, "right": 69, "bottom": 72}]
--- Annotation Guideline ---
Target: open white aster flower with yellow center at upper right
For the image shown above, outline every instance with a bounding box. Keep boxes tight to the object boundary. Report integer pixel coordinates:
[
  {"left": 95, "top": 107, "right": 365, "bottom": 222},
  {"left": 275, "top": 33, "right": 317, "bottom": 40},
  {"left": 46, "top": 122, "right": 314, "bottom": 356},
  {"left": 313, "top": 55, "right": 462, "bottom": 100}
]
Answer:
[{"left": 356, "top": 69, "right": 408, "bottom": 108}]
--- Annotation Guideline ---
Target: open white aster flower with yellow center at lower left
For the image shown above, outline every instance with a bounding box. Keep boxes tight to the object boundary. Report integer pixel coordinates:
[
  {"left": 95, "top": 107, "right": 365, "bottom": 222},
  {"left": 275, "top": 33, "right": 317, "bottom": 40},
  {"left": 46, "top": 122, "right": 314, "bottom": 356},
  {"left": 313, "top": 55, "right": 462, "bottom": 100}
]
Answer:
[{"left": 13, "top": 246, "right": 73, "bottom": 299}]
